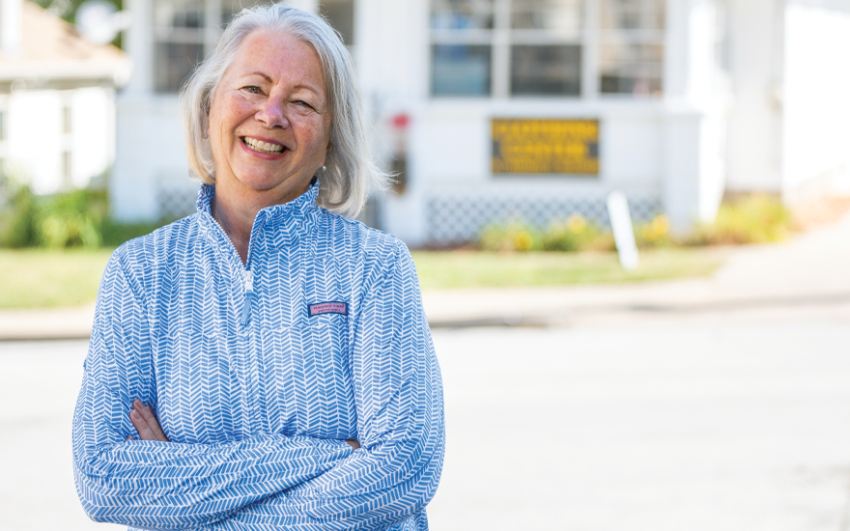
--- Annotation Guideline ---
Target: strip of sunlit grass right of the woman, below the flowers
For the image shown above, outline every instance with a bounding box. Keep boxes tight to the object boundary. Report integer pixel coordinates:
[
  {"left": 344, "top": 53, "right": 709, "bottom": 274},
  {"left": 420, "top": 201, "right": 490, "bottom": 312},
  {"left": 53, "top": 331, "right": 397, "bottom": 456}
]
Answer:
[{"left": 413, "top": 248, "right": 727, "bottom": 289}]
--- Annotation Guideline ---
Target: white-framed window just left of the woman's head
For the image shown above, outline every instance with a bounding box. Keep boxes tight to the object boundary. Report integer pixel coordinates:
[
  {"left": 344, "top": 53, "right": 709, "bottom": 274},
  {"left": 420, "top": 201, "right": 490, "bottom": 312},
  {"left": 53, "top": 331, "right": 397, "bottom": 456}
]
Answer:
[{"left": 153, "top": 0, "right": 271, "bottom": 93}]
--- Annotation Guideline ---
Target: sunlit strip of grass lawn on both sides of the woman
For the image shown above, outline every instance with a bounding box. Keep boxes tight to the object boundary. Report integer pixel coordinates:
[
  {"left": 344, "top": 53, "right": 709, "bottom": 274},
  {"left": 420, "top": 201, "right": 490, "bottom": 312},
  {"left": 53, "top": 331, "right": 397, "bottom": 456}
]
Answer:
[{"left": 0, "top": 248, "right": 726, "bottom": 308}]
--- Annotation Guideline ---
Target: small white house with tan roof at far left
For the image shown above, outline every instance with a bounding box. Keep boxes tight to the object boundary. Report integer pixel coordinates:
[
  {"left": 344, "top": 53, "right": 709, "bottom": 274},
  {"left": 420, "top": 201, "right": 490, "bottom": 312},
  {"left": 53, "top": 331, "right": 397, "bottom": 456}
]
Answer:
[{"left": 0, "top": 0, "right": 130, "bottom": 194}]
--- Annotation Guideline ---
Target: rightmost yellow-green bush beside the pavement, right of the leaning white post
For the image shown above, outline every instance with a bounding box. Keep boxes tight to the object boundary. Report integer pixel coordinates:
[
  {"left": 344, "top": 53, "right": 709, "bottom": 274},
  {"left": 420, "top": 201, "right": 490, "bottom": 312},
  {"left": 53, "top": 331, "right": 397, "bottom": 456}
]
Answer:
[{"left": 684, "top": 195, "right": 793, "bottom": 245}]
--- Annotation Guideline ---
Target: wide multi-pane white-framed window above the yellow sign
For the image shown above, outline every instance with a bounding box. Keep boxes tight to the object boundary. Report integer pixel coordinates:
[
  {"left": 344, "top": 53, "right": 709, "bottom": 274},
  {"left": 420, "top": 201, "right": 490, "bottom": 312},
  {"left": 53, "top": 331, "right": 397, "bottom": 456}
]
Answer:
[{"left": 431, "top": 0, "right": 665, "bottom": 97}]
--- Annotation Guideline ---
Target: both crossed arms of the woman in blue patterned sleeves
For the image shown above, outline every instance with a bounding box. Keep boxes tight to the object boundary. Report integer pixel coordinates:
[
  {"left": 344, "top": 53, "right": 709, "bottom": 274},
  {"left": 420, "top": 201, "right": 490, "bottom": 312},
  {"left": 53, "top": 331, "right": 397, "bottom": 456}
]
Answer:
[{"left": 74, "top": 245, "right": 444, "bottom": 531}]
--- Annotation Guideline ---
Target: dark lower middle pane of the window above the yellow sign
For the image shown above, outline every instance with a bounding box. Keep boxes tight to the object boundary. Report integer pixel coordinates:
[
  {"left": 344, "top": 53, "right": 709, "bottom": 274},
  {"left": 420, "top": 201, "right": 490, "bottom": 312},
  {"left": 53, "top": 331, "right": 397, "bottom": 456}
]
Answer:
[{"left": 511, "top": 45, "right": 581, "bottom": 96}]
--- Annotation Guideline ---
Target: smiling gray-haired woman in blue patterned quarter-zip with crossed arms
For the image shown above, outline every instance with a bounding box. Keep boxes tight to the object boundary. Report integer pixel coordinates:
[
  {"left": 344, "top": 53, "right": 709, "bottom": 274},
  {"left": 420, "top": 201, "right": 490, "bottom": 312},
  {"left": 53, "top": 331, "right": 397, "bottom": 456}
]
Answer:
[{"left": 74, "top": 4, "right": 444, "bottom": 530}]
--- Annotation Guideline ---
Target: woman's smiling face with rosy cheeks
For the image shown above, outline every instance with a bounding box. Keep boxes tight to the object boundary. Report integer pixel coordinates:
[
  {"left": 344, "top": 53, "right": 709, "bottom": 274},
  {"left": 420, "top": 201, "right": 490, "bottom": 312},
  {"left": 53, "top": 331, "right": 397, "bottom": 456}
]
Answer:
[{"left": 208, "top": 31, "right": 331, "bottom": 203}]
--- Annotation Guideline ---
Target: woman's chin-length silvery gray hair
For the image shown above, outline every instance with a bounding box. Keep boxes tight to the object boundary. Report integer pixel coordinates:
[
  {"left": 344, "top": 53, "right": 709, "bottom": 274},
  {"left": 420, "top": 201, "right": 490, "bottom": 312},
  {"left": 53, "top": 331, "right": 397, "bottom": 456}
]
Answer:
[{"left": 180, "top": 4, "right": 388, "bottom": 216}]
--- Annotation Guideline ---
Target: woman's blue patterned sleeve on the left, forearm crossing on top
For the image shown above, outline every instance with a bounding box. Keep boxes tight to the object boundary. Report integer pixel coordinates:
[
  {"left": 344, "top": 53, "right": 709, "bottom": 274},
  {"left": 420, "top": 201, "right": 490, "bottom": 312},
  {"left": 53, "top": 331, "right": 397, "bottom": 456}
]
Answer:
[{"left": 73, "top": 249, "right": 352, "bottom": 530}]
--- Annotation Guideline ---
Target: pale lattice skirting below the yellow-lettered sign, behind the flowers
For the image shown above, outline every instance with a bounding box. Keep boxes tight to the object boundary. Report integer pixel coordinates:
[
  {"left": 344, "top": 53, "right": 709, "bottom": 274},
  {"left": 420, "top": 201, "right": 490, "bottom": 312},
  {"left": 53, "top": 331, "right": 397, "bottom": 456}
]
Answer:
[{"left": 426, "top": 194, "right": 662, "bottom": 245}]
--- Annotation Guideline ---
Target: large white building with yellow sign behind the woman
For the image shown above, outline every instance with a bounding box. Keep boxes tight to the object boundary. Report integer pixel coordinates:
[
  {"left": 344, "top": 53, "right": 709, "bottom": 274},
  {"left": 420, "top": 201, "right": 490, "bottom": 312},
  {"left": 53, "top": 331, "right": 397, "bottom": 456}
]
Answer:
[{"left": 112, "top": 0, "right": 850, "bottom": 245}]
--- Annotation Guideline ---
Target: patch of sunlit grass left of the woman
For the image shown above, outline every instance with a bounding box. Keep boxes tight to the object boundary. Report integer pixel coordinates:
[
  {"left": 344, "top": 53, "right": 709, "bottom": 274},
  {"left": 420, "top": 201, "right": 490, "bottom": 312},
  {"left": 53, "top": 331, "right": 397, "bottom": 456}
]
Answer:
[{"left": 0, "top": 249, "right": 112, "bottom": 308}]
